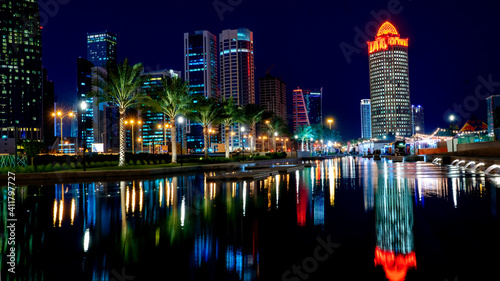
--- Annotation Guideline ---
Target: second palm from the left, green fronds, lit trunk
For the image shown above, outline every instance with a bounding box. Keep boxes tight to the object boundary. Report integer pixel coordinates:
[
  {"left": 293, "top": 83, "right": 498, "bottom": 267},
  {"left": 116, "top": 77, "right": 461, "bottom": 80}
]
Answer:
[{"left": 147, "top": 77, "right": 192, "bottom": 163}]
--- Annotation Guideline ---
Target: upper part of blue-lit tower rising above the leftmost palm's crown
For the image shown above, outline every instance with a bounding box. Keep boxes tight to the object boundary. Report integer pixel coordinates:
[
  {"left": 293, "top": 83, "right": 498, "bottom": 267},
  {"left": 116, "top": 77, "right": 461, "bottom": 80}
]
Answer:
[{"left": 87, "top": 31, "right": 116, "bottom": 66}]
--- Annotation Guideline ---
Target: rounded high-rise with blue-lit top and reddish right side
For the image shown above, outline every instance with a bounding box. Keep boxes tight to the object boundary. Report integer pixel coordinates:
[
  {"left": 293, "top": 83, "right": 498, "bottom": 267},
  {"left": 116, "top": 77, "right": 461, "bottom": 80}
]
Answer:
[{"left": 219, "top": 28, "right": 255, "bottom": 150}]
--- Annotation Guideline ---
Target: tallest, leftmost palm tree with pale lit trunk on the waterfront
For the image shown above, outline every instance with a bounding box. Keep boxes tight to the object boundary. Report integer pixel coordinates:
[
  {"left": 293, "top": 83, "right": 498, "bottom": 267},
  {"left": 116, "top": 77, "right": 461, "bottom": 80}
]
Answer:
[{"left": 89, "top": 59, "right": 148, "bottom": 166}]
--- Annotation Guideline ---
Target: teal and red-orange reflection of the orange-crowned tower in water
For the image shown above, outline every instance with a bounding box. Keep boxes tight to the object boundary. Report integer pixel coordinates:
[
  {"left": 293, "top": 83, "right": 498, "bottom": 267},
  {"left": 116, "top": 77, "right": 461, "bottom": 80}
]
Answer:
[{"left": 375, "top": 177, "right": 417, "bottom": 281}]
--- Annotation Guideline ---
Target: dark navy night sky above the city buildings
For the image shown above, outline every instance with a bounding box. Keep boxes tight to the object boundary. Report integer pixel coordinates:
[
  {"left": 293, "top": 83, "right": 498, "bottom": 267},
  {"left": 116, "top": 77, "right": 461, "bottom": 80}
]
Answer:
[{"left": 39, "top": 0, "right": 500, "bottom": 140}]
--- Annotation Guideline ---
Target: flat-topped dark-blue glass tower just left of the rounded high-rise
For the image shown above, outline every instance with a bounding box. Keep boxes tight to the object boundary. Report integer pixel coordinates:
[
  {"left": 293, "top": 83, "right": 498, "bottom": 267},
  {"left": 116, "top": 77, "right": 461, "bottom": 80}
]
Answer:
[{"left": 184, "top": 30, "right": 219, "bottom": 152}]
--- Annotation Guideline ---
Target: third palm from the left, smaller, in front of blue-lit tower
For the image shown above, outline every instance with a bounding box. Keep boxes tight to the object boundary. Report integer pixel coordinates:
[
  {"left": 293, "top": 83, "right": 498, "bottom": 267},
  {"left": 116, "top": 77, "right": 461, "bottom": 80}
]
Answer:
[{"left": 188, "top": 95, "right": 222, "bottom": 158}]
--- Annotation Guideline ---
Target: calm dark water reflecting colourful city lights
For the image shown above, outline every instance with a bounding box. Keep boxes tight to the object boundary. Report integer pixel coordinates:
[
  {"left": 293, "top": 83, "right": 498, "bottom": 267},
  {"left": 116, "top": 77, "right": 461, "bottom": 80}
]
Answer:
[{"left": 0, "top": 157, "right": 500, "bottom": 281}]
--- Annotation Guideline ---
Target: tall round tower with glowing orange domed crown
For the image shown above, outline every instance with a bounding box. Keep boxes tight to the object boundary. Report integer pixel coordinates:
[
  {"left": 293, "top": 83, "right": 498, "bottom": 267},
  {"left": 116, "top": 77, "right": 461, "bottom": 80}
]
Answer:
[{"left": 368, "top": 21, "right": 412, "bottom": 138}]
